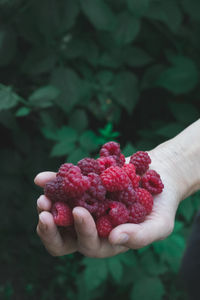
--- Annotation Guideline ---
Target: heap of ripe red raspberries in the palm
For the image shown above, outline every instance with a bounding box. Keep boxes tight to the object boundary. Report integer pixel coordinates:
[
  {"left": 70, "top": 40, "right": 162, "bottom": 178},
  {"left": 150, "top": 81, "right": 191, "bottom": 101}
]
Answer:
[{"left": 44, "top": 142, "right": 164, "bottom": 238}]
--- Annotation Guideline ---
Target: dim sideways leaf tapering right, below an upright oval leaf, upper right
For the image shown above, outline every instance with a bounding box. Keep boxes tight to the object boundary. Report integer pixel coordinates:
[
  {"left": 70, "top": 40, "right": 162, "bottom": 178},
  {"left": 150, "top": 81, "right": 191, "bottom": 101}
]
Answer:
[{"left": 123, "top": 47, "right": 153, "bottom": 67}]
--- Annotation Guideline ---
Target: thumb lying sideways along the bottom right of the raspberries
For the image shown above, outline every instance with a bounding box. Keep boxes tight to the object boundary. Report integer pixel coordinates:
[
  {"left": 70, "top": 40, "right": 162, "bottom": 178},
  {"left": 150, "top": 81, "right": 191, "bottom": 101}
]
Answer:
[{"left": 109, "top": 217, "right": 174, "bottom": 249}]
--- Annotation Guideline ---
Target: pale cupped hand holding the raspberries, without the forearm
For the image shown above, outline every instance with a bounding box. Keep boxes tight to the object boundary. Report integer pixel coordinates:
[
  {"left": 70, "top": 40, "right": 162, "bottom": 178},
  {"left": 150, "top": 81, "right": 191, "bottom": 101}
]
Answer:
[{"left": 35, "top": 148, "right": 181, "bottom": 258}]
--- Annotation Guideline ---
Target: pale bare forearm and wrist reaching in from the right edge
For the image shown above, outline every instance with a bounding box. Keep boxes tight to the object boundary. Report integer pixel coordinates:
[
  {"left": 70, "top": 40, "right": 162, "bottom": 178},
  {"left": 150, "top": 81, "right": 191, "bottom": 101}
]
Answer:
[{"left": 151, "top": 119, "right": 200, "bottom": 200}]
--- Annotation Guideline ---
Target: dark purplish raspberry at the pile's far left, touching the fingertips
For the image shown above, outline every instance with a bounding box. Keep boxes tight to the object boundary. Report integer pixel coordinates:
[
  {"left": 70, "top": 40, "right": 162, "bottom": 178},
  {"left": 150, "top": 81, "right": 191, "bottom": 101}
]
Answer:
[{"left": 44, "top": 178, "right": 68, "bottom": 202}]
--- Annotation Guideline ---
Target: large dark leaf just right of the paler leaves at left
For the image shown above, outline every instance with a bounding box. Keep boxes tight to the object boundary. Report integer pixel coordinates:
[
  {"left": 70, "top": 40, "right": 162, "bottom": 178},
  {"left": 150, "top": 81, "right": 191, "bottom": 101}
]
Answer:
[{"left": 51, "top": 67, "right": 83, "bottom": 113}]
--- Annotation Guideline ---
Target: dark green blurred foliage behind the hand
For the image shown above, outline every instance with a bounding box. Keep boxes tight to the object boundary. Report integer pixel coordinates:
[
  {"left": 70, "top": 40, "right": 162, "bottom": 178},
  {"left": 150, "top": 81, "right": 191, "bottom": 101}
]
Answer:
[{"left": 0, "top": 0, "right": 200, "bottom": 300}]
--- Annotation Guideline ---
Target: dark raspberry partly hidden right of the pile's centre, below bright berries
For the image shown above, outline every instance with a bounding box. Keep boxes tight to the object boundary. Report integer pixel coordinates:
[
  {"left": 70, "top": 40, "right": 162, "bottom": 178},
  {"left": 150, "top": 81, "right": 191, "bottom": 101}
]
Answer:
[{"left": 111, "top": 184, "right": 137, "bottom": 206}]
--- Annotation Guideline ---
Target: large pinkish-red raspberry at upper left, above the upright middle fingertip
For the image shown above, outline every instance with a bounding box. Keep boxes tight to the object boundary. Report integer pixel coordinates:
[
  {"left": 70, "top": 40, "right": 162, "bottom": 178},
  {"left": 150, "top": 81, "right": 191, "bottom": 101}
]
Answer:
[{"left": 62, "top": 166, "right": 90, "bottom": 197}]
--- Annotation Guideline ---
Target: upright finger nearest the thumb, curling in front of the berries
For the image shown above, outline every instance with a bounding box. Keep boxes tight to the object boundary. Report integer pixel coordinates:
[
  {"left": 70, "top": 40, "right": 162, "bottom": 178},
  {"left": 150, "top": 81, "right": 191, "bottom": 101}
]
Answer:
[{"left": 73, "top": 207, "right": 100, "bottom": 256}]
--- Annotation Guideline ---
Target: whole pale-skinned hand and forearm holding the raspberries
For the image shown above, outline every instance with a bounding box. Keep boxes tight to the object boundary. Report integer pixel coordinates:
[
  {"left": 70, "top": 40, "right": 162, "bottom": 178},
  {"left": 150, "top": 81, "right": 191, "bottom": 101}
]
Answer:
[{"left": 35, "top": 119, "right": 200, "bottom": 258}]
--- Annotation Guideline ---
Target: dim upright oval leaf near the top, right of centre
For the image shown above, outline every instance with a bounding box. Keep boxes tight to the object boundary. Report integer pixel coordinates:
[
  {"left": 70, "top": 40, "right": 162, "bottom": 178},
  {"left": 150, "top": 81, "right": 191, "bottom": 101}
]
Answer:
[{"left": 112, "top": 11, "right": 140, "bottom": 45}]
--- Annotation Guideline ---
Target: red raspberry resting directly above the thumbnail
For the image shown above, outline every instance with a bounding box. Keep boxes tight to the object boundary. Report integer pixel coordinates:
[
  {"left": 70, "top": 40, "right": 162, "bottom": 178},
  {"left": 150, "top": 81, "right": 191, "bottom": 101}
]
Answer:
[{"left": 109, "top": 201, "right": 129, "bottom": 226}]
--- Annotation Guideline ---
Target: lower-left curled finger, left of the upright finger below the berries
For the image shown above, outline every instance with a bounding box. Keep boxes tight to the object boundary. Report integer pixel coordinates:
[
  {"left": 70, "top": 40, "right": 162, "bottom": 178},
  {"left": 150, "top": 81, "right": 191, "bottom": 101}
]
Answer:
[{"left": 37, "top": 211, "right": 77, "bottom": 256}]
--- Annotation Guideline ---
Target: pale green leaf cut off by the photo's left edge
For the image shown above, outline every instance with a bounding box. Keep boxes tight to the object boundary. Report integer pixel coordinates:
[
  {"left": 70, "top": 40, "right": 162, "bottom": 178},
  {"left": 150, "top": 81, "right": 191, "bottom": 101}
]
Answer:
[{"left": 0, "top": 84, "right": 20, "bottom": 111}]
